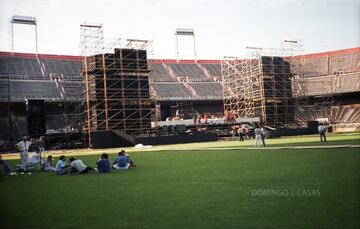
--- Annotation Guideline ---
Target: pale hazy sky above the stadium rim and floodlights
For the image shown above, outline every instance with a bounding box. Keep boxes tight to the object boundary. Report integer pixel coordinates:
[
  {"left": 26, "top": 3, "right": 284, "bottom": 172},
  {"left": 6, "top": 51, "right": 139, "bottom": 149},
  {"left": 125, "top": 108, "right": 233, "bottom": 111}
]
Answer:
[{"left": 0, "top": 0, "right": 360, "bottom": 59}]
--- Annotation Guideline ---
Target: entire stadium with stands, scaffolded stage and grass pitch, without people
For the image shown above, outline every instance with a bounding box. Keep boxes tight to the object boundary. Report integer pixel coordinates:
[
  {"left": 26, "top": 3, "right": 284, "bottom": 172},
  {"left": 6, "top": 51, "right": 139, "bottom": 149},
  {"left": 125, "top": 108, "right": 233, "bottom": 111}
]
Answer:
[{"left": 0, "top": 1, "right": 360, "bottom": 228}]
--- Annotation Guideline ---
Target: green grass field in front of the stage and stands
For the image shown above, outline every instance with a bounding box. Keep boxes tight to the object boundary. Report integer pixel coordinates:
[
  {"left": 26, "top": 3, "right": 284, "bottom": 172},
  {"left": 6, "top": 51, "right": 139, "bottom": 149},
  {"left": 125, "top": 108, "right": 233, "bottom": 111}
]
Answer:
[{"left": 0, "top": 133, "right": 360, "bottom": 229}]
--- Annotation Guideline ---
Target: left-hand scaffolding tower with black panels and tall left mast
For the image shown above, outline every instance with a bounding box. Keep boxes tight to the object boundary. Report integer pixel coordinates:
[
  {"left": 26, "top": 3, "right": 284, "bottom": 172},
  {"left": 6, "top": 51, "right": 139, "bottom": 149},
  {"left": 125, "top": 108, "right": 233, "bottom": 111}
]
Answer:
[{"left": 80, "top": 24, "right": 154, "bottom": 147}]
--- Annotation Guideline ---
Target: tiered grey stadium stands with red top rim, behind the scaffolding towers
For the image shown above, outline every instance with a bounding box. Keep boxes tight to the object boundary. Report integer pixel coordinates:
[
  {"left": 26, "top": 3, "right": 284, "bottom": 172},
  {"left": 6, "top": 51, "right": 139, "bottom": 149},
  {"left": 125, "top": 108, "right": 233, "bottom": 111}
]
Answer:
[{"left": 0, "top": 48, "right": 360, "bottom": 148}]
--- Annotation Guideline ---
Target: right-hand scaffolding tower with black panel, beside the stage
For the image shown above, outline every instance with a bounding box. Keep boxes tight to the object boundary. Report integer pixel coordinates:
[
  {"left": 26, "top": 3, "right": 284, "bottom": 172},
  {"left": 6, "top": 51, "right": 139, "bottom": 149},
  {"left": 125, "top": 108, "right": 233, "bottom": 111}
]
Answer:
[{"left": 221, "top": 44, "right": 294, "bottom": 127}]
